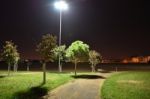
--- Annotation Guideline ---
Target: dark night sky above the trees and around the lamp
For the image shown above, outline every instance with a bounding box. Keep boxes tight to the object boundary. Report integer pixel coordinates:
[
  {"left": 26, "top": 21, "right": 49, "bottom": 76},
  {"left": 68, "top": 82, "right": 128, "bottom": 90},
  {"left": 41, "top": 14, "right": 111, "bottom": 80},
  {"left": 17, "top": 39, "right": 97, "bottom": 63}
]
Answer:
[{"left": 0, "top": 0, "right": 150, "bottom": 59}]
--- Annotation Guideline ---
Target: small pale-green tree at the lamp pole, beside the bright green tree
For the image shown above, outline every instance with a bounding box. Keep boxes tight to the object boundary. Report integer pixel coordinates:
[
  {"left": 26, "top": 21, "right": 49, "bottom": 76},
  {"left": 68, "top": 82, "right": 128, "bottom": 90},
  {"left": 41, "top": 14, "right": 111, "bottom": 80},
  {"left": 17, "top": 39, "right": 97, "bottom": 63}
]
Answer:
[{"left": 52, "top": 45, "right": 66, "bottom": 72}]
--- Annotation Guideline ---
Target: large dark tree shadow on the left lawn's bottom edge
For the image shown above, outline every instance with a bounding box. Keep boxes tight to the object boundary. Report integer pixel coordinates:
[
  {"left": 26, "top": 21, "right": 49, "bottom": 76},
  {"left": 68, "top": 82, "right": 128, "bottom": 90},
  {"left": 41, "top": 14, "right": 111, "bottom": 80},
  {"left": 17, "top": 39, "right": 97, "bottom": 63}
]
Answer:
[{"left": 13, "top": 84, "right": 48, "bottom": 99}]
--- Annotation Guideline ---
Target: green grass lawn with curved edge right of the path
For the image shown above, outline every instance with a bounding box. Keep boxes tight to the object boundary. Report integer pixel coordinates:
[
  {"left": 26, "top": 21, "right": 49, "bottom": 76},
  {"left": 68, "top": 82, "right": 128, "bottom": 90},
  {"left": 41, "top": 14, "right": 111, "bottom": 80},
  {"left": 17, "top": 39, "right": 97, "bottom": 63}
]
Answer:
[{"left": 101, "top": 72, "right": 150, "bottom": 99}]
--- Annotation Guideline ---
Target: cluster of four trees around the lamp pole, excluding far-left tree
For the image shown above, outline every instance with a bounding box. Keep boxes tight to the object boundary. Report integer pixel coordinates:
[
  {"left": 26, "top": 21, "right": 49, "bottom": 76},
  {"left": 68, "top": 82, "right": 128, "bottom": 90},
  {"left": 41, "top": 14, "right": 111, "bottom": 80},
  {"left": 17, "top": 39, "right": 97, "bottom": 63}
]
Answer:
[{"left": 37, "top": 34, "right": 102, "bottom": 83}]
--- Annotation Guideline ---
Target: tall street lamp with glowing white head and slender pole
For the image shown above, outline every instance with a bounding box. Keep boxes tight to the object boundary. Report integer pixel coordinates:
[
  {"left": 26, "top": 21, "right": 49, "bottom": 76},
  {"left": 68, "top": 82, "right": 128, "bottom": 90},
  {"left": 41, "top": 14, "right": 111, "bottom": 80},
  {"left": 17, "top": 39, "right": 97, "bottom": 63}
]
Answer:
[{"left": 54, "top": 0, "right": 68, "bottom": 72}]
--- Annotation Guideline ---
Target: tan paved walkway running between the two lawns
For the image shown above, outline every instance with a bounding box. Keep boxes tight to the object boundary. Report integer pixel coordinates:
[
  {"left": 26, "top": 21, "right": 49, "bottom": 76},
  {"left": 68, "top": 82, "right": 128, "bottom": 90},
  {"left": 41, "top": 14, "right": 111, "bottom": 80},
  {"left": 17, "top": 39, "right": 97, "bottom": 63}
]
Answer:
[{"left": 44, "top": 74, "right": 110, "bottom": 99}]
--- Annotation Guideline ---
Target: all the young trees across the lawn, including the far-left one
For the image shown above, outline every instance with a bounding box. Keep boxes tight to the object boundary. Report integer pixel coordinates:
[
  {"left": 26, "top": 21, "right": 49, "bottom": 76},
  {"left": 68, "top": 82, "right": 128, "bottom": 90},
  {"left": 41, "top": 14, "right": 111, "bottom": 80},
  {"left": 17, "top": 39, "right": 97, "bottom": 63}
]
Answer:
[{"left": 1, "top": 34, "right": 102, "bottom": 83}]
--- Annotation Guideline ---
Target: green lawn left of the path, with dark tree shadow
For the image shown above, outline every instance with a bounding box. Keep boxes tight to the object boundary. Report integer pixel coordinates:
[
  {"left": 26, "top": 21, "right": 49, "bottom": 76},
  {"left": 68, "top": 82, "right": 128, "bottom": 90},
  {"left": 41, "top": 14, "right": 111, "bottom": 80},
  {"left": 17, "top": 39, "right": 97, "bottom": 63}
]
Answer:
[{"left": 0, "top": 71, "right": 73, "bottom": 99}]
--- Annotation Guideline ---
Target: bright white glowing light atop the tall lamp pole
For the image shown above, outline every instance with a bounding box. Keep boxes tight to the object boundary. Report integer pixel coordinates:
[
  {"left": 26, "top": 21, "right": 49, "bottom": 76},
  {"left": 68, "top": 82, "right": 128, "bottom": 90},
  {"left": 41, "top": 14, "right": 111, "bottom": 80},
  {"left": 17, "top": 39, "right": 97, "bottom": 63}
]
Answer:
[{"left": 54, "top": 0, "right": 68, "bottom": 10}]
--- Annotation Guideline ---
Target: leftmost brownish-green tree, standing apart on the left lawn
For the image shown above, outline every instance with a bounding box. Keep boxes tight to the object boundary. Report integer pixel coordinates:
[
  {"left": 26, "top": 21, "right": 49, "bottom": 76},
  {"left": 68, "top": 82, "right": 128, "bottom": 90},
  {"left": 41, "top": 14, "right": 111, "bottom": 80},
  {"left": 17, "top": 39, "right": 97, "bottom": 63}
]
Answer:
[{"left": 2, "top": 41, "right": 20, "bottom": 75}]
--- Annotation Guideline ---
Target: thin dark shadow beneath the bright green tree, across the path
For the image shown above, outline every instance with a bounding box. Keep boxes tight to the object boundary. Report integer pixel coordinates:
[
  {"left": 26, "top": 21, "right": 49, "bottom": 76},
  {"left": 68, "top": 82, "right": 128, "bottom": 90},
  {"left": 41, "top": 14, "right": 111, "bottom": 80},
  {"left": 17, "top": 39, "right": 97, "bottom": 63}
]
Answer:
[{"left": 72, "top": 75, "right": 105, "bottom": 79}]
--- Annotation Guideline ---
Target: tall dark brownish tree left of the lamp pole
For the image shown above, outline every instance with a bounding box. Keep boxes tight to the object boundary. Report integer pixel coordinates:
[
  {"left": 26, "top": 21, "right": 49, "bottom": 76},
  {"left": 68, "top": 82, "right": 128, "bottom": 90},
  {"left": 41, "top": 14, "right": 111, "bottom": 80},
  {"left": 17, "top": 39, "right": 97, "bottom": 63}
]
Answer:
[{"left": 36, "top": 34, "right": 57, "bottom": 84}]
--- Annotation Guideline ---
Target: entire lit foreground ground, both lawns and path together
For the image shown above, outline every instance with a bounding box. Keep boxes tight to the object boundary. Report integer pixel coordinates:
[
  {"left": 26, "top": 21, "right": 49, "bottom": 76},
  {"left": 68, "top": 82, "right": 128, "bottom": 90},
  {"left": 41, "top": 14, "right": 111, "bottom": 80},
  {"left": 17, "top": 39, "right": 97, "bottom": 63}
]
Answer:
[{"left": 0, "top": 71, "right": 150, "bottom": 99}]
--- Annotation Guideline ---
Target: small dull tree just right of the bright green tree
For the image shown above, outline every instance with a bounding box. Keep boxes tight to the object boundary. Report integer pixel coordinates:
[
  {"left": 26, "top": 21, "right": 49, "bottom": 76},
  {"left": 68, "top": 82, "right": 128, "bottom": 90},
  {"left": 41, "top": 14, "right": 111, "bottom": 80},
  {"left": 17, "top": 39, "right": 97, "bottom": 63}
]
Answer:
[{"left": 89, "top": 50, "right": 102, "bottom": 72}]
